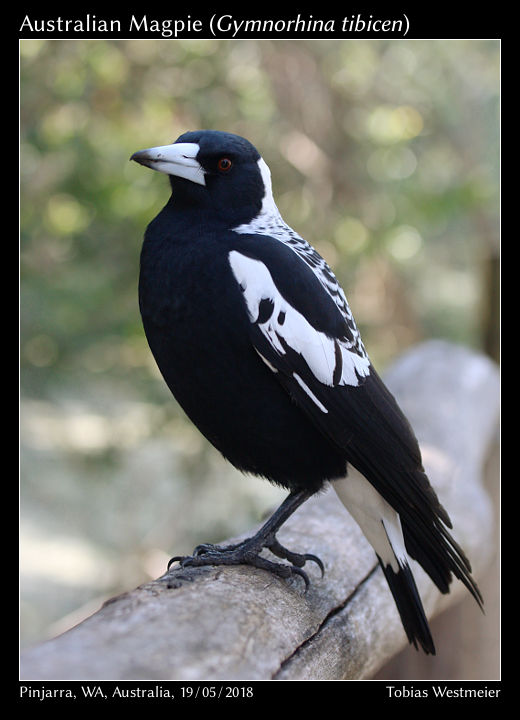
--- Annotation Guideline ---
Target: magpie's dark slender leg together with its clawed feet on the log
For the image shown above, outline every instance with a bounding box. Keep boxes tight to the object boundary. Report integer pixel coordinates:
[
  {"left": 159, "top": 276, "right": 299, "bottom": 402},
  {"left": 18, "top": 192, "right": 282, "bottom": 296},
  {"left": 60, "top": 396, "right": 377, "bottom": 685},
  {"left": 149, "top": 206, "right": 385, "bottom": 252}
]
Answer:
[{"left": 168, "top": 490, "right": 324, "bottom": 589}]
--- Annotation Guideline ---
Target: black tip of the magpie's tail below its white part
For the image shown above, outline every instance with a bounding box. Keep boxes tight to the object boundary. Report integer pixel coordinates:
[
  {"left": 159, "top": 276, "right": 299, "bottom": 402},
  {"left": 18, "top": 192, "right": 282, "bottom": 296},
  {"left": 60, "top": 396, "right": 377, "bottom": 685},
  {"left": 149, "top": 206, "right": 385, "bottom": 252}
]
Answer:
[{"left": 378, "top": 556, "right": 435, "bottom": 655}]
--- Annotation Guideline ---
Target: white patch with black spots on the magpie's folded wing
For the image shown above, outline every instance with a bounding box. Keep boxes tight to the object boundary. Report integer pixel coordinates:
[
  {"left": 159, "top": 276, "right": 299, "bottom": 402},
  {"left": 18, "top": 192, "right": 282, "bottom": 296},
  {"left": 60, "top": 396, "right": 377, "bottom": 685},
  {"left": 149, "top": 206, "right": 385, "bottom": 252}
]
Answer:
[{"left": 229, "top": 250, "right": 370, "bottom": 402}]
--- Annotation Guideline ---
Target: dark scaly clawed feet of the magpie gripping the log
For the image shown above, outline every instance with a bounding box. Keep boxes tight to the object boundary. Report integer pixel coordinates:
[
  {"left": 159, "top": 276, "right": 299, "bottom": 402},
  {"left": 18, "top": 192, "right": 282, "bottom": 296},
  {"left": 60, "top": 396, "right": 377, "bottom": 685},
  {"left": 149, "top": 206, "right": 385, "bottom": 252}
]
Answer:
[{"left": 168, "top": 534, "right": 325, "bottom": 592}]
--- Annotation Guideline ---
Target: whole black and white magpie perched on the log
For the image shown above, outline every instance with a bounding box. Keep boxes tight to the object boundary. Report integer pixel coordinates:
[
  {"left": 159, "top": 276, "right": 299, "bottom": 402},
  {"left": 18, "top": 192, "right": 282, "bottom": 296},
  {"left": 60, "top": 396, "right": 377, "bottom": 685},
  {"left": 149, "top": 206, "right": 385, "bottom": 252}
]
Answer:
[{"left": 131, "top": 130, "right": 482, "bottom": 653}]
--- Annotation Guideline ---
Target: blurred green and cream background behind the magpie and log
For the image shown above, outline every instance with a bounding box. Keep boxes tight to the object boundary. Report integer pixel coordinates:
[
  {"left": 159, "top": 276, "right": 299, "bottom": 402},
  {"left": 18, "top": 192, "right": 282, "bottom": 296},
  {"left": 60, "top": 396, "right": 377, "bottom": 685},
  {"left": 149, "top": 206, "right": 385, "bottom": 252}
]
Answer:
[{"left": 20, "top": 40, "right": 500, "bottom": 664}]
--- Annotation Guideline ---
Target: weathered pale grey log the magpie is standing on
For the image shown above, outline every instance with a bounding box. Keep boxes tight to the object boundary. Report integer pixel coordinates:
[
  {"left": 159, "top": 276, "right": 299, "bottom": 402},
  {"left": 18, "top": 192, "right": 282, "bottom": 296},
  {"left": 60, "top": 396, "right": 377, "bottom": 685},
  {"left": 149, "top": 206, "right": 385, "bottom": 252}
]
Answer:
[{"left": 21, "top": 342, "right": 498, "bottom": 680}]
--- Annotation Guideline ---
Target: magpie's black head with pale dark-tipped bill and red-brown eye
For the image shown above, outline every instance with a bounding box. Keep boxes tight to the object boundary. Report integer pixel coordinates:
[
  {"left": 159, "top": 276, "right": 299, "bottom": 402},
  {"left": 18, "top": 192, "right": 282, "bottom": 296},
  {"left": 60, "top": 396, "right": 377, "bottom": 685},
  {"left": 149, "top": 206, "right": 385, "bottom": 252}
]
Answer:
[{"left": 130, "top": 130, "right": 274, "bottom": 227}]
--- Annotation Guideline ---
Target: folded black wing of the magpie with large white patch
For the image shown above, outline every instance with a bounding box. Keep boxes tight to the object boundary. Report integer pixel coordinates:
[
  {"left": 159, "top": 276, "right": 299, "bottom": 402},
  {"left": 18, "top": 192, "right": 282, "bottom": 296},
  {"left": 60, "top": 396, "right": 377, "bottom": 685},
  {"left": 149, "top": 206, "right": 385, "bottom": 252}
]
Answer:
[{"left": 229, "top": 238, "right": 481, "bottom": 604}]
